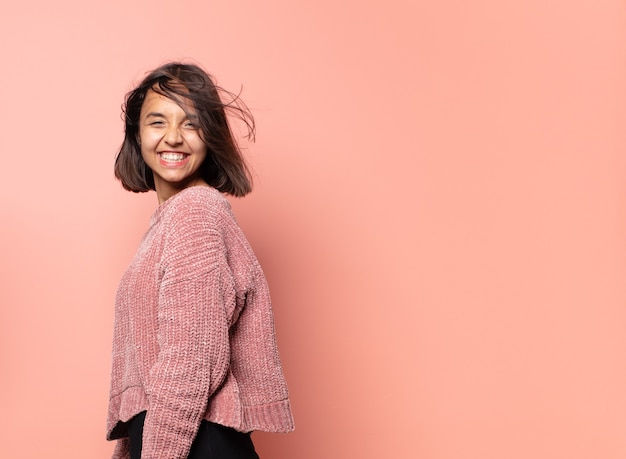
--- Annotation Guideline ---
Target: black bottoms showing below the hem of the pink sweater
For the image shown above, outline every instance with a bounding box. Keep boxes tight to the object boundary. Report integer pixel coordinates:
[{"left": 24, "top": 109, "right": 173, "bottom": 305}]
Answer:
[{"left": 128, "top": 411, "right": 259, "bottom": 459}]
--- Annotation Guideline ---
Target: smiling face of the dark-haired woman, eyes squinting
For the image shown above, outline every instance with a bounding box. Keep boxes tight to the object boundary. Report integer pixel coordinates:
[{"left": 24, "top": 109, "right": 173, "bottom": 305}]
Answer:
[{"left": 139, "top": 90, "right": 207, "bottom": 202}]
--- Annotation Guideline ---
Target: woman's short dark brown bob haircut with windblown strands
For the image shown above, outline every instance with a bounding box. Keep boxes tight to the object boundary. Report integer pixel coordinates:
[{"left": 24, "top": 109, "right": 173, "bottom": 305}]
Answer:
[{"left": 115, "top": 62, "right": 255, "bottom": 196}]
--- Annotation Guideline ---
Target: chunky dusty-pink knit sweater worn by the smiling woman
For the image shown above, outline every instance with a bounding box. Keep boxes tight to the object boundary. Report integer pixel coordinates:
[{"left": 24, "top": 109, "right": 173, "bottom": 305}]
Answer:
[{"left": 107, "top": 186, "right": 293, "bottom": 459}]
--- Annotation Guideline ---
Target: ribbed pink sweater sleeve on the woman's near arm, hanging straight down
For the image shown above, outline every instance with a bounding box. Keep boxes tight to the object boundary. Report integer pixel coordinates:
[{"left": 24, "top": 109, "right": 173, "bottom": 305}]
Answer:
[{"left": 141, "top": 206, "right": 230, "bottom": 459}]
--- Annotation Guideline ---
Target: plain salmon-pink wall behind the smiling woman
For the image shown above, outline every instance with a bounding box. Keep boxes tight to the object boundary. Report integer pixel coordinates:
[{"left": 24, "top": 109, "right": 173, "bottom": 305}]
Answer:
[{"left": 0, "top": 0, "right": 626, "bottom": 459}]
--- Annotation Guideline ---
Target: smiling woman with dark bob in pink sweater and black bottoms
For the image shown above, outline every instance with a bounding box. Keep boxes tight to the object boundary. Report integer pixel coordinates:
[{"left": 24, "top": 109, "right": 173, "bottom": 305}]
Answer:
[{"left": 107, "top": 63, "right": 293, "bottom": 459}]
